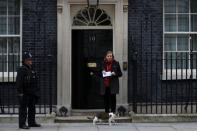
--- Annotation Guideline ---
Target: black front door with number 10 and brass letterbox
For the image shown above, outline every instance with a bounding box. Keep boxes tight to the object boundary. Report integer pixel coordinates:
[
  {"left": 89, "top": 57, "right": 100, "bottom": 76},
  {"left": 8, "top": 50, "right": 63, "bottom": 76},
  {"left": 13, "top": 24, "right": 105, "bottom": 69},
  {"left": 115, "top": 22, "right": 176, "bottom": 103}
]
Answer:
[{"left": 72, "top": 30, "right": 113, "bottom": 109}]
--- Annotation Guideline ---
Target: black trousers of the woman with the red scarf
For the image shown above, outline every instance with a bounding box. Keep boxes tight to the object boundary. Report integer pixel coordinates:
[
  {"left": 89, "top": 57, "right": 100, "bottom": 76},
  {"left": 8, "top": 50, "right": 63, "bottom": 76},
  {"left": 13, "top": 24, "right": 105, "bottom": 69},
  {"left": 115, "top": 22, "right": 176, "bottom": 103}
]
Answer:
[{"left": 104, "top": 87, "right": 116, "bottom": 113}]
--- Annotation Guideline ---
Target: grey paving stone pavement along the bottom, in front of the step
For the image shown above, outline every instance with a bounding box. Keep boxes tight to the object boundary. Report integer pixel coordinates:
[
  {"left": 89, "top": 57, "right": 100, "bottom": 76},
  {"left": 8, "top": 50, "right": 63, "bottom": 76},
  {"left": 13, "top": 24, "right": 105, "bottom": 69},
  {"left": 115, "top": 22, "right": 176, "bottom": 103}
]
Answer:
[{"left": 0, "top": 123, "right": 197, "bottom": 131}]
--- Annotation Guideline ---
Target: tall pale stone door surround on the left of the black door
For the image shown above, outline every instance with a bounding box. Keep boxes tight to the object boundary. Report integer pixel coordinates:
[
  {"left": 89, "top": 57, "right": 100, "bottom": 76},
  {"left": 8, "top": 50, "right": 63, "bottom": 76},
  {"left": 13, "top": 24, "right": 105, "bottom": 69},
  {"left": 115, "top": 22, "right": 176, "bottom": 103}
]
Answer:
[{"left": 57, "top": 0, "right": 72, "bottom": 111}]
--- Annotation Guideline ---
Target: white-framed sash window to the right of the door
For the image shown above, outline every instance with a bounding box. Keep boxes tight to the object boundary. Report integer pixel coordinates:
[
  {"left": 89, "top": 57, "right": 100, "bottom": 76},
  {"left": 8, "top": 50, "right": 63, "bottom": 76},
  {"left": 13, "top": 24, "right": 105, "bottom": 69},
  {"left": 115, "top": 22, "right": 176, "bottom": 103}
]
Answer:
[{"left": 163, "top": 0, "right": 197, "bottom": 69}]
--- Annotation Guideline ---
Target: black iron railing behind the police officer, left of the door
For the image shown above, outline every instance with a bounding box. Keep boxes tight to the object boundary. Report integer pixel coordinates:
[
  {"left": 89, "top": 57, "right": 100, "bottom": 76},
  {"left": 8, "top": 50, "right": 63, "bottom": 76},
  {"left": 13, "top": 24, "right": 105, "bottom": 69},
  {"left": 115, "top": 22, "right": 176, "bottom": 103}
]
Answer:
[{"left": 0, "top": 56, "right": 56, "bottom": 114}]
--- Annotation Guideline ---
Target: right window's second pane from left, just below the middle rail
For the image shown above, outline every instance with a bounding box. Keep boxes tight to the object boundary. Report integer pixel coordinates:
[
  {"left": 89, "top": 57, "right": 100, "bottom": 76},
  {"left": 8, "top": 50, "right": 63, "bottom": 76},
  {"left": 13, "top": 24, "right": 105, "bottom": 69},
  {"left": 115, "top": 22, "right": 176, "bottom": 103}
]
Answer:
[{"left": 177, "top": 35, "right": 189, "bottom": 51}]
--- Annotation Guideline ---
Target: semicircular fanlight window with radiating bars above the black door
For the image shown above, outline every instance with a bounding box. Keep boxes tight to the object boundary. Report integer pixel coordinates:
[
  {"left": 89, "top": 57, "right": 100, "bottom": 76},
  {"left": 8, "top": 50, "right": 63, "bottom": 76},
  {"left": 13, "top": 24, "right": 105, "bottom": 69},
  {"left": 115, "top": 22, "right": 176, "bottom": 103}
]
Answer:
[{"left": 73, "top": 7, "right": 112, "bottom": 26}]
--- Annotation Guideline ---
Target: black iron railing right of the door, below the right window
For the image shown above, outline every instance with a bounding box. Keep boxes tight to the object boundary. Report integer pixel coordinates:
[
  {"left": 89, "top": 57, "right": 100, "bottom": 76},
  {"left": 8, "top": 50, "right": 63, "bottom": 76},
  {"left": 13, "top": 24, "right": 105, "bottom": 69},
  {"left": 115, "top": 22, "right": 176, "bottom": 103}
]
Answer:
[{"left": 132, "top": 53, "right": 197, "bottom": 114}]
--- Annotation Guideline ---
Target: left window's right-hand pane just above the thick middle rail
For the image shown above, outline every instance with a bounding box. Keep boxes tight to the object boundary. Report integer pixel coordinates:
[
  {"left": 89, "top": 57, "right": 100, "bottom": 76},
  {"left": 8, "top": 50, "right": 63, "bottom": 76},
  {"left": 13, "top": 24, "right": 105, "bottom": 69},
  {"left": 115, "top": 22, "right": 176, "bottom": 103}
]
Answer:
[{"left": 8, "top": 17, "right": 20, "bottom": 35}]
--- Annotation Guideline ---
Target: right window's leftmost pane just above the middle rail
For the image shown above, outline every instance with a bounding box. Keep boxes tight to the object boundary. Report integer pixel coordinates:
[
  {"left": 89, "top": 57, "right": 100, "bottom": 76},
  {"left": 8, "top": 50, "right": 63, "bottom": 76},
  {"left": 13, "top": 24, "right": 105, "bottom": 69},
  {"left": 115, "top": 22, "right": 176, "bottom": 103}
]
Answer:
[{"left": 165, "top": 15, "right": 177, "bottom": 32}]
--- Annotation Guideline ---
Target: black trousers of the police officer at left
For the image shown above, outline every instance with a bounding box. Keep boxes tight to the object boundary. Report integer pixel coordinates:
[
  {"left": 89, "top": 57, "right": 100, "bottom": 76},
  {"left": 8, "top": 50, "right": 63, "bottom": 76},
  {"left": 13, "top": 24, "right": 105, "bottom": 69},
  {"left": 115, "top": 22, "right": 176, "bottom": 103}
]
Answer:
[{"left": 19, "top": 95, "right": 35, "bottom": 127}]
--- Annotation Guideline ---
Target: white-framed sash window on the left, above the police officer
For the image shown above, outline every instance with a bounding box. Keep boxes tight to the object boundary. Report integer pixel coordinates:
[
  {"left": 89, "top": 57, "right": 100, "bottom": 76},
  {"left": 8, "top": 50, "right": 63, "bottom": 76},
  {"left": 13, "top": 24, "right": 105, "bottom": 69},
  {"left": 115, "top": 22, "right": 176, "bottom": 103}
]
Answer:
[{"left": 0, "top": 0, "right": 21, "bottom": 76}]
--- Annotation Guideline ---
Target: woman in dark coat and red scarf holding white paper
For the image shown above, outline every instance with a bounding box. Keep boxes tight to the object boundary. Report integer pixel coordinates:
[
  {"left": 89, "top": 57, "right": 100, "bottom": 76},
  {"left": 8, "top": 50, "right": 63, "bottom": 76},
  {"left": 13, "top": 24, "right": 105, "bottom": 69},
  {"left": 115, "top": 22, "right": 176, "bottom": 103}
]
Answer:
[{"left": 100, "top": 51, "right": 122, "bottom": 113}]
